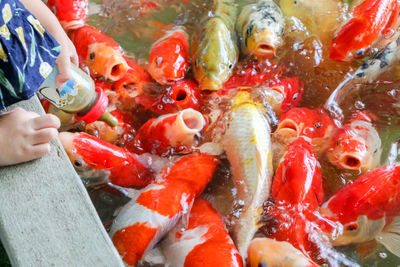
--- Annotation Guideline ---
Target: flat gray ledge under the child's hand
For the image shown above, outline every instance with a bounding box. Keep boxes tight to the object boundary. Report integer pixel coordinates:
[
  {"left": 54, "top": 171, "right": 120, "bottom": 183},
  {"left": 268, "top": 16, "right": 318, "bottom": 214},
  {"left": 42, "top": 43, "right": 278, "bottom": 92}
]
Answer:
[{"left": 0, "top": 97, "right": 123, "bottom": 267}]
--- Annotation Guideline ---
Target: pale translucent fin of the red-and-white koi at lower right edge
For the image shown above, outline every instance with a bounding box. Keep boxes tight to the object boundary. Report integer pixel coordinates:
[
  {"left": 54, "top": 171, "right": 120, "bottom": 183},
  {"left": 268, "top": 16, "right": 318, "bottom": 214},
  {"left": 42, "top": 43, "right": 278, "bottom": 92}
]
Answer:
[{"left": 376, "top": 216, "right": 400, "bottom": 257}]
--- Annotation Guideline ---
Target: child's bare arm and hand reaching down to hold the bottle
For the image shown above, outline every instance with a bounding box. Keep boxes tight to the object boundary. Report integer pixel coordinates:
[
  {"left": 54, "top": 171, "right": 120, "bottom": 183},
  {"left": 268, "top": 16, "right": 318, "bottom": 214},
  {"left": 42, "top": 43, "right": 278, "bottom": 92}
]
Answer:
[{"left": 20, "top": 0, "right": 79, "bottom": 86}]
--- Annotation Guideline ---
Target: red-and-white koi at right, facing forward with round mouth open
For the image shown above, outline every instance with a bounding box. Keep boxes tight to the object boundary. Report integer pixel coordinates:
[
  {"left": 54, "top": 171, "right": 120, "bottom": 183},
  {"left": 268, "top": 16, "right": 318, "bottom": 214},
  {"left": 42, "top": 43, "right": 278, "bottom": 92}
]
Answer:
[{"left": 327, "top": 112, "right": 381, "bottom": 172}]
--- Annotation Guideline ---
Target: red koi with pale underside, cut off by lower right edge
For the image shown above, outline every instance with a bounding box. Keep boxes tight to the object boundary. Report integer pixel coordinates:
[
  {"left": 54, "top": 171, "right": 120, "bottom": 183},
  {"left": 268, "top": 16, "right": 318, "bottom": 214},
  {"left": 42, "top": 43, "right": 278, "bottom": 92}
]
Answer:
[{"left": 320, "top": 166, "right": 400, "bottom": 257}]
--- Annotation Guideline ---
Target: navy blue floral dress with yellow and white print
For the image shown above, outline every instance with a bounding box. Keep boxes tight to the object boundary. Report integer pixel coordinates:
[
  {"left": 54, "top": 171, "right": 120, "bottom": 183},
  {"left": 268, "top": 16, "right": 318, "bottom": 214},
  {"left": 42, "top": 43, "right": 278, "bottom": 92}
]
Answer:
[{"left": 0, "top": 0, "right": 61, "bottom": 110}]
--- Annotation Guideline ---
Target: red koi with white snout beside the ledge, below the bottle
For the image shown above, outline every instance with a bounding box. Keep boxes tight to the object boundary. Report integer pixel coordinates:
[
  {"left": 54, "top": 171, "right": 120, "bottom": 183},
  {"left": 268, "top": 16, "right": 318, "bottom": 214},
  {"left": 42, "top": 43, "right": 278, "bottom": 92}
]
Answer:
[{"left": 59, "top": 132, "right": 154, "bottom": 188}]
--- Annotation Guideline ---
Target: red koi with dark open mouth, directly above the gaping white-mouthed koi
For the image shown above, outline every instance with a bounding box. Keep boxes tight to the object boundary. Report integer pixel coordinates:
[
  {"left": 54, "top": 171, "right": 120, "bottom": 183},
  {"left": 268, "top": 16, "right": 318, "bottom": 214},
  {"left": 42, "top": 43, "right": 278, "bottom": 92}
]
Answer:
[{"left": 136, "top": 79, "right": 200, "bottom": 114}]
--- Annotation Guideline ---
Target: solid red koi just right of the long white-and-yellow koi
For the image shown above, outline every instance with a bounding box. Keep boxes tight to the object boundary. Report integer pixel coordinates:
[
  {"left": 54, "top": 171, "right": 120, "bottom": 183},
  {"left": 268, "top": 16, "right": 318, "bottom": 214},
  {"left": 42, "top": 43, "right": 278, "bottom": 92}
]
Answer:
[{"left": 269, "top": 137, "right": 324, "bottom": 253}]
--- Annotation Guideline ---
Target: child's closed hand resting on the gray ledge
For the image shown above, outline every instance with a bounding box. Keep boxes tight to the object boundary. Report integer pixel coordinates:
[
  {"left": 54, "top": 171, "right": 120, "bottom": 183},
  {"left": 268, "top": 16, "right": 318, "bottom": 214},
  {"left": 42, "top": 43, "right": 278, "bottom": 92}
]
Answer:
[{"left": 0, "top": 108, "right": 60, "bottom": 166}]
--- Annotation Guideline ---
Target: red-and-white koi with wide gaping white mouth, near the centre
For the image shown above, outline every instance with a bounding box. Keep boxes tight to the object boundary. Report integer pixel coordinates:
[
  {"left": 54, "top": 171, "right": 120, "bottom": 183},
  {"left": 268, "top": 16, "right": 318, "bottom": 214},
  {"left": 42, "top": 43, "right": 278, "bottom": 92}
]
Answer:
[{"left": 134, "top": 108, "right": 206, "bottom": 155}]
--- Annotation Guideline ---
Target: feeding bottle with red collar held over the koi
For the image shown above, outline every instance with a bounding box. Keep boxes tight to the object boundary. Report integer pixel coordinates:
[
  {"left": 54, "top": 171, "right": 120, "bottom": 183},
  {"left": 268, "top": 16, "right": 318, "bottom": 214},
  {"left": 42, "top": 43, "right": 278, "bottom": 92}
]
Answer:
[{"left": 39, "top": 64, "right": 118, "bottom": 127}]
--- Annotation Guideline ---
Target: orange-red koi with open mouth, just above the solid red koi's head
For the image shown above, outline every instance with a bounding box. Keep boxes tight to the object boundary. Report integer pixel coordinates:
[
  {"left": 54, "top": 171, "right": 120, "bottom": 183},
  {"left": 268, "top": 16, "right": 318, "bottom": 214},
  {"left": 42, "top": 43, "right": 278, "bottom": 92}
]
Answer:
[{"left": 274, "top": 107, "right": 337, "bottom": 153}]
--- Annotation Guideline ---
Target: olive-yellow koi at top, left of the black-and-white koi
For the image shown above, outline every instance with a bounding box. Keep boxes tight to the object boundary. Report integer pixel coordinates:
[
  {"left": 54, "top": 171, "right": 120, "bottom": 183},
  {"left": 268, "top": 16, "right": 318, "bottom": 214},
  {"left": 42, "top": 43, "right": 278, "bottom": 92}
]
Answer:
[{"left": 192, "top": 0, "right": 238, "bottom": 90}]
